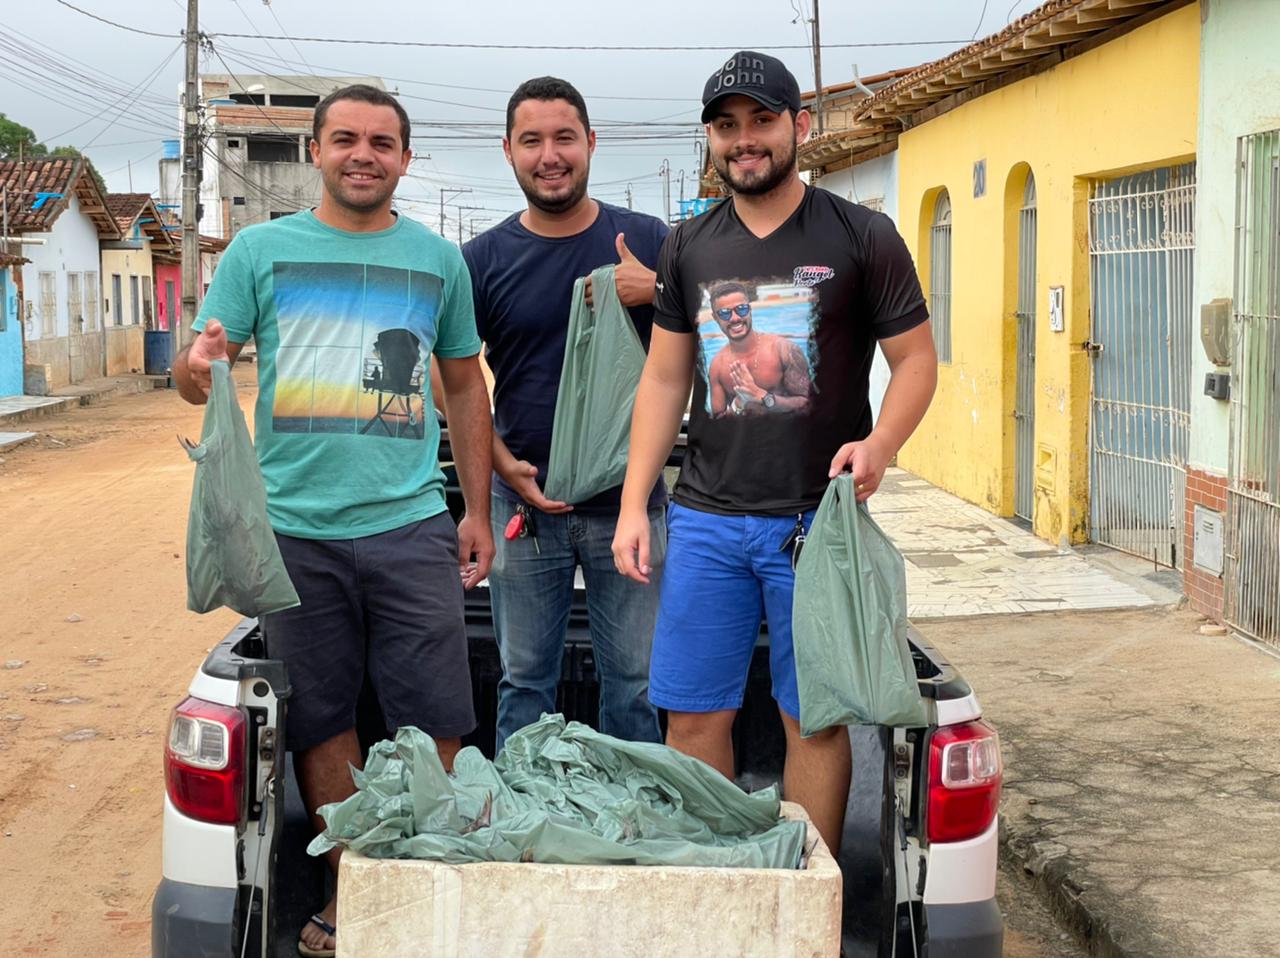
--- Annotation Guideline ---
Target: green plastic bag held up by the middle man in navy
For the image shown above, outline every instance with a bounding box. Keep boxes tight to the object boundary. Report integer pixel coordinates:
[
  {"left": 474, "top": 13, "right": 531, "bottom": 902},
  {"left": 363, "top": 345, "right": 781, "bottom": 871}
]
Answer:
[{"left": 544, "top": 266, "right": 645, "bottom": 502}]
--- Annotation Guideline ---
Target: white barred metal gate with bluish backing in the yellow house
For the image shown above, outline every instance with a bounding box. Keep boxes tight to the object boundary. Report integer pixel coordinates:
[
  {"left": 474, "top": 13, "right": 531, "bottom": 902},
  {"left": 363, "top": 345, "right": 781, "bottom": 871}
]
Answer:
[{"left": 1085, "top": 164, "right": 1196, "bottom": 569}]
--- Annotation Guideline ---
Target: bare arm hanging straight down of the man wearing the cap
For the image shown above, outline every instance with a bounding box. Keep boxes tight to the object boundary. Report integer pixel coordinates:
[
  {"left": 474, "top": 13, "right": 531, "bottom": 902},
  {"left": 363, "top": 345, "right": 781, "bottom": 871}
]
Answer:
[{"left": 613, "top": 325, "right": 695, "bottom": 583}]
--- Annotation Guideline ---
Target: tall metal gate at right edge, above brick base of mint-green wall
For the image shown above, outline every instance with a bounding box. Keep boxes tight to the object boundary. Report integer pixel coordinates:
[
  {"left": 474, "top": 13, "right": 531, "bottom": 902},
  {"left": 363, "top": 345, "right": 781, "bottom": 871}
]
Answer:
[{"left": 1225, "top": 131, "right": 1280, "bottom": 644}]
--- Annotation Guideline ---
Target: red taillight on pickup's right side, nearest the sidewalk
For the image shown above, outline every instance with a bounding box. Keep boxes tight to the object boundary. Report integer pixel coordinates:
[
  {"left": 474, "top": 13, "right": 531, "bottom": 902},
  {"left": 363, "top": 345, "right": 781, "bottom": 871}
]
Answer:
[{"left": 928, "top": 721, "right": 1002, "bottom": 841}]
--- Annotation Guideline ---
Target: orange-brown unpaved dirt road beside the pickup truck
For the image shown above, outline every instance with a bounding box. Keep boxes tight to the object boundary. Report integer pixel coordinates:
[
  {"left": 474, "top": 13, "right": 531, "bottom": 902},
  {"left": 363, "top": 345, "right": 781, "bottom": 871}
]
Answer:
[{"left": 0, "top": 368, "right": 1078, "bottom": 958}]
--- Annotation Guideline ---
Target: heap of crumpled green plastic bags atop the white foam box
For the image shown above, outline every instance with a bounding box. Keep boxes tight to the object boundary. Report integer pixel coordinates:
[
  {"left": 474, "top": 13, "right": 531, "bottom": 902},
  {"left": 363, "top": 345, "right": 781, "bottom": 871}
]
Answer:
[{"left": 307, "top": 715, "right": 805, "bottom": 868}]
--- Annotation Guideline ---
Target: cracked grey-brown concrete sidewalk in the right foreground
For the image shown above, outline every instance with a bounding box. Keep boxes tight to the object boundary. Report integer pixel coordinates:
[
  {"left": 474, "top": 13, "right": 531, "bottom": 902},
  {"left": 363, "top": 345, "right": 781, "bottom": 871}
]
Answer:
[{"left": 923, "top": 607, "right": 1280, "bottom": 958}]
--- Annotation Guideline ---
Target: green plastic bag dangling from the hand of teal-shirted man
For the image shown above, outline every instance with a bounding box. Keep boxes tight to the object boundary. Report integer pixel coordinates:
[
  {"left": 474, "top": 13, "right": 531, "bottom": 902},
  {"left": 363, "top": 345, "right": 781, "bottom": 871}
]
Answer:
[{"left": 182, "top": 361, "right": 298, "bottom": 616}]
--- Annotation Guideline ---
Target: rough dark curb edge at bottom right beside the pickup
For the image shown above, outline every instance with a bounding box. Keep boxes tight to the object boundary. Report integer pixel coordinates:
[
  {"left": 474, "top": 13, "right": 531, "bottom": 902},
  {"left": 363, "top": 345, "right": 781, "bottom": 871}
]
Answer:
[{"left": 1000, "top": 817, "right": 1152, "bottom": 958}]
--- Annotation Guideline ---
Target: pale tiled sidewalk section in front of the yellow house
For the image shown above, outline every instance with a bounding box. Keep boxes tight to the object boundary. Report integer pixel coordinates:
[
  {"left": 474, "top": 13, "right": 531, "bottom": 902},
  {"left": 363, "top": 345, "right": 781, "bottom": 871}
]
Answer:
[{"left": 870, "top": 469, "right": 1181, "bottom": 620}]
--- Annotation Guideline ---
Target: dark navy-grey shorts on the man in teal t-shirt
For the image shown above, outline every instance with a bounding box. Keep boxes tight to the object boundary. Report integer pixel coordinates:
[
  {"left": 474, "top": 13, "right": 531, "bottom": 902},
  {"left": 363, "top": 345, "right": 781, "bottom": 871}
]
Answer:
[{"left": 262, "top": 512, "right": 476, "bottom": 752}]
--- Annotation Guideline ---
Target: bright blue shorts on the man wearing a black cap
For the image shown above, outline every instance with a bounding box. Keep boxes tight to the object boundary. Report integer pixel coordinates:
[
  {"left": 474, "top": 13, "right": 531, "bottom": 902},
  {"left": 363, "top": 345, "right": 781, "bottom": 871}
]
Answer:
[{"left": 649, "top": 502, "right": 813, "bottom": 719}]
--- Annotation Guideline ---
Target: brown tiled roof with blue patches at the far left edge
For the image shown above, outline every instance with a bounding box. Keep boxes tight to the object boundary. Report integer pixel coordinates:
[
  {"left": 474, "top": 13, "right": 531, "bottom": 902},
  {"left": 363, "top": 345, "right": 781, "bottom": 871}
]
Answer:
[{"left": 0, "top": 156, "right": 120, "bottom": 240}]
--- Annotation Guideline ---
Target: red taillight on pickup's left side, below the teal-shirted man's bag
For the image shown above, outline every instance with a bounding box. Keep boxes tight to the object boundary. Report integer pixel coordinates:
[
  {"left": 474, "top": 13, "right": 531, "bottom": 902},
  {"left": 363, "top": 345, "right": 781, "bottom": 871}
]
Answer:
[{"left": 164, "top": 698, "right": 247, "bottom": 825}]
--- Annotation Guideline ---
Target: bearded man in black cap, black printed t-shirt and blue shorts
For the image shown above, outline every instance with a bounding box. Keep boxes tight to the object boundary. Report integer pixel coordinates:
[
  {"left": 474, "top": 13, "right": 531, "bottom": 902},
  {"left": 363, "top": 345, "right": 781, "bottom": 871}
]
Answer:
[{"left": 613, "top": 51, "right": 937, "bottom": 850}]
